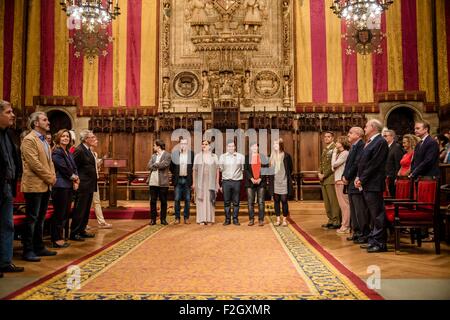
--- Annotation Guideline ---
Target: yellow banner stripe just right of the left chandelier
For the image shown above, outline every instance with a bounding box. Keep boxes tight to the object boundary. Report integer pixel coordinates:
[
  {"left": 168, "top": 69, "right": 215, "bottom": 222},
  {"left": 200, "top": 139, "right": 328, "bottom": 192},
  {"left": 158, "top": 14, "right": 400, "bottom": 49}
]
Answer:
[{"left": 112, "top": 0, "right": 128, "bottom": 107}]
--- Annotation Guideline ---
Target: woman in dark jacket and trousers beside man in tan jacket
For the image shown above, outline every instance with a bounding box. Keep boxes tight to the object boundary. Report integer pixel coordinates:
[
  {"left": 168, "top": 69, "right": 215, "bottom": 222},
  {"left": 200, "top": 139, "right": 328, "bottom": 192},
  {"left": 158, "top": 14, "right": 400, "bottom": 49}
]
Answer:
[{"left": 51, "top": 129, "right": 80, "bottom": 248}]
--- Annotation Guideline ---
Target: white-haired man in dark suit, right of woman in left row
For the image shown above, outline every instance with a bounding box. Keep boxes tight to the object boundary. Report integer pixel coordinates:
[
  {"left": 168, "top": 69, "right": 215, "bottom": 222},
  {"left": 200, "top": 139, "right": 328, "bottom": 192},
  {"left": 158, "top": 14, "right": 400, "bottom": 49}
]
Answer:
[{"left": 70, "top": 130, "right": 97, "bottom": 241}]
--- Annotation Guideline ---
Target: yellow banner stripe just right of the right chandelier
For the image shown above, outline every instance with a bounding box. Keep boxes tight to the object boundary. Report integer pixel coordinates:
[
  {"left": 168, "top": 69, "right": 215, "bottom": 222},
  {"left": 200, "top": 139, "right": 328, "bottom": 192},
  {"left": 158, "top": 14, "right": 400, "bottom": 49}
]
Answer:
[{"left": 386, "top": 1, "right": 404, "bottom": 91}]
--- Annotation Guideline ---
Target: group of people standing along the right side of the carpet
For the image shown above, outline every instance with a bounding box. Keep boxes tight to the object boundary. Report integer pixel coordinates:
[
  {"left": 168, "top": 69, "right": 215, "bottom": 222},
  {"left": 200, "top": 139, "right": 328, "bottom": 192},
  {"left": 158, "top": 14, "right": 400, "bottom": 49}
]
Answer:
[{"left": 319, "top": 119, "right": 439, "bottom": 253}]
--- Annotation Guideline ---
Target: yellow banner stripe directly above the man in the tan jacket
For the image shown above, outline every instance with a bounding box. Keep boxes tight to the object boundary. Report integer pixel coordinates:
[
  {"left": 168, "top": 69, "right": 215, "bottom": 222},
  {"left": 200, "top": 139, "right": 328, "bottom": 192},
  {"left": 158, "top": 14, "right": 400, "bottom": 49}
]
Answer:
[{"left": 25, "top": 0, "right": 41, "bottom": 106}]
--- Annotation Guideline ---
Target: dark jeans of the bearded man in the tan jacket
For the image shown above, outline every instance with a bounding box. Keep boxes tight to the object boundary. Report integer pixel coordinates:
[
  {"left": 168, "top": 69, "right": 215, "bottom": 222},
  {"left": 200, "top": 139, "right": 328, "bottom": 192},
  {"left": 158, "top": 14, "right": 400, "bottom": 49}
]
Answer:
[{"left": 23, "top": 191, "right": 50, "bottom": 254}]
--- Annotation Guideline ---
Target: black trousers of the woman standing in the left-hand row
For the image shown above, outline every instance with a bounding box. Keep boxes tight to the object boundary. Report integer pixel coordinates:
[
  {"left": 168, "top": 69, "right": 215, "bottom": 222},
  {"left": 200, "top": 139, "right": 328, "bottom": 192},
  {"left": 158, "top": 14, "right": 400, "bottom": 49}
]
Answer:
[{"left": 51, "top": 188, "right": 73, "bottom": 242}]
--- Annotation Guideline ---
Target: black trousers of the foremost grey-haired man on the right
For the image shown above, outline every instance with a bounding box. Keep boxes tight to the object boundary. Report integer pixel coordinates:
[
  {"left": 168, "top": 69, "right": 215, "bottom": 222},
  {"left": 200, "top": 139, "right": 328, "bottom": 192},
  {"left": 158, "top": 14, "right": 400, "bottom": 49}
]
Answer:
[{"left": 363, "top": 191, "right": 387, "bottom": 247}]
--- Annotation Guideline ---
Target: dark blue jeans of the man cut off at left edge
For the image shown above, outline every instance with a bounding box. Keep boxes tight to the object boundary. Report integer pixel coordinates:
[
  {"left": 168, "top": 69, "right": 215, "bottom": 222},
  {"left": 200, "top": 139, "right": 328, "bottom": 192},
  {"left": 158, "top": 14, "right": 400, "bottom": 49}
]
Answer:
[{"left": 0, "top": 183, "right": 14, "bottom": 267}]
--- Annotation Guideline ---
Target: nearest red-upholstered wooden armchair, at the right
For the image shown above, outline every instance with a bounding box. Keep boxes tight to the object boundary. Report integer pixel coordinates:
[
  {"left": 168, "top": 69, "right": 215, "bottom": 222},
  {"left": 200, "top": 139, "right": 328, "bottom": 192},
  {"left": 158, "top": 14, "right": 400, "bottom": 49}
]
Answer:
[{"left": 392, "top": 177, "right": 440, "bottom": 254}]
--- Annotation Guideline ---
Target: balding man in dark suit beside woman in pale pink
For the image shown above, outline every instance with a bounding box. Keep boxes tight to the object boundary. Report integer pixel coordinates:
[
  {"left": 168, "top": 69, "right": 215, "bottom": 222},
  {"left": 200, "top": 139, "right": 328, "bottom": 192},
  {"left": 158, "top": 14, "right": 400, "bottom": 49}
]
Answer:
[{"left": 342, "top": 127, "right": 370, "bottom": 244}]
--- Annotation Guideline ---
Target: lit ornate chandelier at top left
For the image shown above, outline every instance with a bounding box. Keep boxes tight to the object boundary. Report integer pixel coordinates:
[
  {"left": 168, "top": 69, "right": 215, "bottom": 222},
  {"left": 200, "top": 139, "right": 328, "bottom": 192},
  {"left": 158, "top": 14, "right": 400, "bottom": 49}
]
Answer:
[{"left": 60, "top": 0, "right": 120, "bottom": 32}]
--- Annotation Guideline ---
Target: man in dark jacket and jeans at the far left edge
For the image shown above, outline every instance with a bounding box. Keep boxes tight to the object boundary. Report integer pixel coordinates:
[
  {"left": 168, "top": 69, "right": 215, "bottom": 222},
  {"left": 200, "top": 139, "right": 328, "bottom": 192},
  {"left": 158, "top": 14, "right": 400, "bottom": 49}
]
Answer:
[{"left": 0, "top": 100, "right": 24, "bottom": 278}]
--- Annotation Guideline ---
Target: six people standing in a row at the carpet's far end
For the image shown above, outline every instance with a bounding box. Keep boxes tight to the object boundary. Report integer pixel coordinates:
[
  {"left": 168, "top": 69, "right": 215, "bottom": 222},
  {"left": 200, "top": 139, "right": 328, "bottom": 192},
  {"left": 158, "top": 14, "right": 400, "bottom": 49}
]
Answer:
[{"left": 147, "top": 138, "right": 293, "bottom": 226}]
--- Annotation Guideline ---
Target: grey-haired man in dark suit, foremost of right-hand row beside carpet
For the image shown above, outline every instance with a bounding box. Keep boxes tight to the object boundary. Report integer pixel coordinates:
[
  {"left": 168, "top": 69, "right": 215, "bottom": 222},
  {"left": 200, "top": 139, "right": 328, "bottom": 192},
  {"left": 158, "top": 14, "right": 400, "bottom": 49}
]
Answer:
[{"left": 354, "top": 119, "right": 389, "bottom": 253}]
